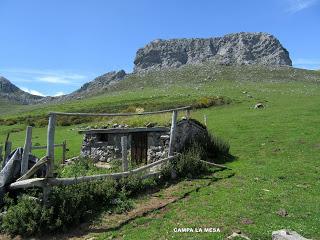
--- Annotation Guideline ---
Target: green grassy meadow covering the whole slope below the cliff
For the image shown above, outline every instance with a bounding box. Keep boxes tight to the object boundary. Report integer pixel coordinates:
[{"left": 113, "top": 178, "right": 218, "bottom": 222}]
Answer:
[{"left": 0, "top": 65, "right": 320, "bottom": 239}]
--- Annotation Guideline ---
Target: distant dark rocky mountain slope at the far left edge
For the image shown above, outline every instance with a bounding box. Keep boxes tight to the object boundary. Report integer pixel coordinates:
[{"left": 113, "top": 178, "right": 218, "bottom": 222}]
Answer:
[{"left": 0, "top": 76, "right": 44, "bottom": 104}]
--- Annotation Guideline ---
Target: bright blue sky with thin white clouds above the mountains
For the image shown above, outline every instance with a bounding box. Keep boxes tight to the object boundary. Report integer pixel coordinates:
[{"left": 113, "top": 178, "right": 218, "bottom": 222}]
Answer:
[{"left": 0, "top": 0, "right": 320, "bottom": 96}]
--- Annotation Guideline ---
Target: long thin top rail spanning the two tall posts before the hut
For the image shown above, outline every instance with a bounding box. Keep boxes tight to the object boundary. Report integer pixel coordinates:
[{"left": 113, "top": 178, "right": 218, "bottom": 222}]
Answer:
[{"left": 49, "top": 106, "right": 191, "bottom": 117}]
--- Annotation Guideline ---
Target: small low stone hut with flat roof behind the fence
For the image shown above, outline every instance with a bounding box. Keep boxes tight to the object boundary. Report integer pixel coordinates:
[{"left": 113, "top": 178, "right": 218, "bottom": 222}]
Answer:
[{"left": 79, "top": 119, "right": 207, "bottom": 164}]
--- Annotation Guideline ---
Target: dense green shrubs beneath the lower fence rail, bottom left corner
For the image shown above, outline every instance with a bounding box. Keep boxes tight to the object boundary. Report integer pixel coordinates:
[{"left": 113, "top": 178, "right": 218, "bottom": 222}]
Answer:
[{"left": 1, "top": 179, "right": 127, "bottom": 236}]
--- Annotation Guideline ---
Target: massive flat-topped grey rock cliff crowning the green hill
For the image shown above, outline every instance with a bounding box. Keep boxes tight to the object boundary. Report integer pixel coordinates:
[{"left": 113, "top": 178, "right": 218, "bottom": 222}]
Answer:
[{"left": 134, "top": 33, "right": 292, "bottom": 72}]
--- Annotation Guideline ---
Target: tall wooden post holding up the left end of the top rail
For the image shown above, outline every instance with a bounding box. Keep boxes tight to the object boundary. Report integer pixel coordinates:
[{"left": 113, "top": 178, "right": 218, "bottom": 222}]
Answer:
[{"left": 46, "top": 114, "right": 56, "bottom": 177}]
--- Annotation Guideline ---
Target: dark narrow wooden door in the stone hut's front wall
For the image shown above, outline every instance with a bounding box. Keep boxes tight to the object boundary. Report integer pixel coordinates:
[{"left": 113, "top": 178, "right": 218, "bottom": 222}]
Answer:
[{"left": 131, "top": 133, "right": 148, "bottom": 165}]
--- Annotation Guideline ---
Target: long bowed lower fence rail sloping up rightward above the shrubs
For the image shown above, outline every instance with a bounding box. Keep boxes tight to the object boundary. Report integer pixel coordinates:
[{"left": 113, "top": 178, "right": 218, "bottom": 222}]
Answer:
[{"left": 10, "top": 155, "right": 178, "bottom": 189}]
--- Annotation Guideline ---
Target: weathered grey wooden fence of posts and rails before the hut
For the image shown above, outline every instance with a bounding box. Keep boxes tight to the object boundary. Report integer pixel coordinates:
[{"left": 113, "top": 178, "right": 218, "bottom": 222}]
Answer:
[{"left": 10, "top": 106, "right": 191, "bottom": 200}]
